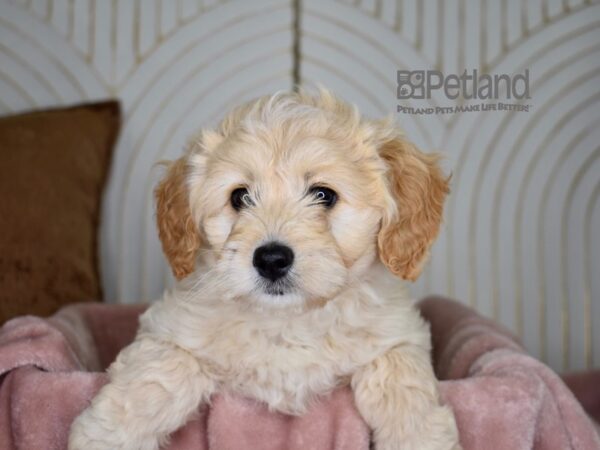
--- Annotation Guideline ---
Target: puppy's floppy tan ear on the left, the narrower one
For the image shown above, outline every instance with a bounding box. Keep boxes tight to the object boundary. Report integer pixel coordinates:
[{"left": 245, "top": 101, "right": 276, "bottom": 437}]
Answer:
[{"left": 154, "top": 156, "right": 201, "bottom": 280}]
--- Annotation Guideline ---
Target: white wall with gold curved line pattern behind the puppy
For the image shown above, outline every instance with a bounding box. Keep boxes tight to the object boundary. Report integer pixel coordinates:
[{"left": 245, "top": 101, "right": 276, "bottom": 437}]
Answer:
[{"left": 0, "top": 0, "right": 600, "bottom": 370}]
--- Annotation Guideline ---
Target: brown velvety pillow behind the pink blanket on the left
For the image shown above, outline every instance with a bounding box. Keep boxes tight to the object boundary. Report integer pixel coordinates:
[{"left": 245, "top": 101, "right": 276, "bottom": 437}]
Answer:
[{"left": 0, "top": 101, "right": 120, "bottom": 323}]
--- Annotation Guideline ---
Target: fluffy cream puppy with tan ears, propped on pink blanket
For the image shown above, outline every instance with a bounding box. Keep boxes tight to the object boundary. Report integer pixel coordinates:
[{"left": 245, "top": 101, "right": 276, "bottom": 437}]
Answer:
[{"left": 69, "top": 91, "right": 459, "bottom": 450}]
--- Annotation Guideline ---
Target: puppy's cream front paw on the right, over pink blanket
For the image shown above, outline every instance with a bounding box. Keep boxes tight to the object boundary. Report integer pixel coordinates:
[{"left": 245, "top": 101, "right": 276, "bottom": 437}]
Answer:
[{"left": 374, "top": 406, "right": 462, "bottom": 450}]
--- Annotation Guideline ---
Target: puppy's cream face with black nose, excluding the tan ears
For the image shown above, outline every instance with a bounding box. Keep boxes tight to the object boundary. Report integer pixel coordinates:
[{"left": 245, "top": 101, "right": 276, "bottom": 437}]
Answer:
[{"left": 190, "top": 130, "right": 385, "bottom": 305}]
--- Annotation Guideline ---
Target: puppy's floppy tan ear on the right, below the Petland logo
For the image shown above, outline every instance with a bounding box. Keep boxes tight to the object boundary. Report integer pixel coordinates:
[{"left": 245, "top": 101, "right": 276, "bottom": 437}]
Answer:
[{"left": 377, "top": 137, "right": 449, "bottom": 280}]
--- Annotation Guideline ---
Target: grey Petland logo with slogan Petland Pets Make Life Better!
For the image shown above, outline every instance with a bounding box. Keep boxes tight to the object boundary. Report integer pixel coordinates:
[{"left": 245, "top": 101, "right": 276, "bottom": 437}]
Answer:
[{"left": 397, "top": 69, "right": 531, "bottom": 114}]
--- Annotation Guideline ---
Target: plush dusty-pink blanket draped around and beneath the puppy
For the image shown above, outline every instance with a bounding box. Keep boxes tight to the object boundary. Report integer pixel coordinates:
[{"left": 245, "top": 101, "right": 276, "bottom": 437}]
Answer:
[{"left": 0, "top": 298, "right": 600, "bottom": 450}]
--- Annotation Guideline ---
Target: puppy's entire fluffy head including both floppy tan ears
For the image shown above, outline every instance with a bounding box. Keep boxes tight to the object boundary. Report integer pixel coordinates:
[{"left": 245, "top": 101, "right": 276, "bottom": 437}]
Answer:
[{"left": 157, "top": 92, "right": 447, "bottom": 307}]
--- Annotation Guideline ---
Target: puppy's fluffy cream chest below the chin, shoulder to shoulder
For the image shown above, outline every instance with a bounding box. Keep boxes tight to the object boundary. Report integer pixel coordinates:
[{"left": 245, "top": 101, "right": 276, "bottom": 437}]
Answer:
[{"left": 142, "top": 284, "right": 429, "bottom": 414}]
